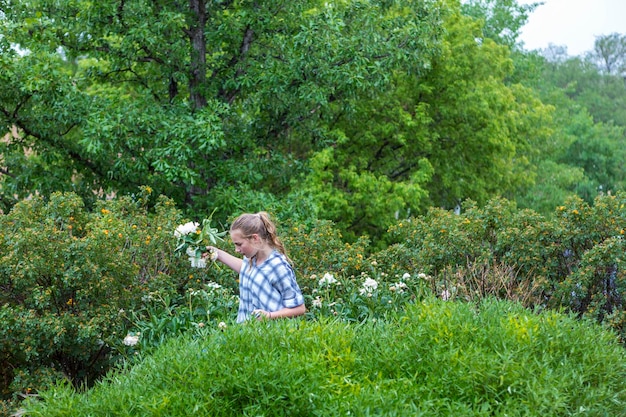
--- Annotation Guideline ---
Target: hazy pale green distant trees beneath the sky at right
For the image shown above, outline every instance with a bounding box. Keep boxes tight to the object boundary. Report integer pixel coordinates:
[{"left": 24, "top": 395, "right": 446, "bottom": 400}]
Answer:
[{"left": 516, "top": 48, "right": 626, "bottom": 214}]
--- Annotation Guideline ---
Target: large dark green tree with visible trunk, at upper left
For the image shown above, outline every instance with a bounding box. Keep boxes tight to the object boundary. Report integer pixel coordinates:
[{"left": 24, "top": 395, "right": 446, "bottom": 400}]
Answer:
[{"left": 0, "top": 0, "right": 439, "bottom": 218}]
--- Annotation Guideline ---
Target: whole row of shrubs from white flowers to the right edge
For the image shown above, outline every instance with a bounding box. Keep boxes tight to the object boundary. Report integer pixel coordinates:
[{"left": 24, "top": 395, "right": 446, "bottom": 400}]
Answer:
[{"left": 381, "top": 193, "right": 626, "bottom": 339}]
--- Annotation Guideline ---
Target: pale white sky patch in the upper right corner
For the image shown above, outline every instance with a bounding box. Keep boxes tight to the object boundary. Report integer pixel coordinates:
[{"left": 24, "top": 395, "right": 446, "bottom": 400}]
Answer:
[{"left": 518, "top": 0, "right": 626, "bottom": 56}]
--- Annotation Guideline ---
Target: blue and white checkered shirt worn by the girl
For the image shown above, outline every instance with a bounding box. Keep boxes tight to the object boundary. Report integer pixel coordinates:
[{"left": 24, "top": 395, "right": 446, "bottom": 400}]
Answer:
[{"left": 237, "top": 250, "right": 304, "bottom": 323}]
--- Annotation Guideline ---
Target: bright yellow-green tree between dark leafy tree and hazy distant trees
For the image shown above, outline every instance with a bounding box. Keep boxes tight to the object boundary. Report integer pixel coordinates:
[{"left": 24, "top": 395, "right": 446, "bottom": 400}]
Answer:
[{"left": 306, "top": 1, "right": 550, "bottom": 239}]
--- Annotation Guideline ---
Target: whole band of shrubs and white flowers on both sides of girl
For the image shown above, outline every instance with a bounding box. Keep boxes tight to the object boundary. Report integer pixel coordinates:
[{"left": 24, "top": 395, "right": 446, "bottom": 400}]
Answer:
[{"left": 0, "top": 189, "right": 626, "bottom": 412}]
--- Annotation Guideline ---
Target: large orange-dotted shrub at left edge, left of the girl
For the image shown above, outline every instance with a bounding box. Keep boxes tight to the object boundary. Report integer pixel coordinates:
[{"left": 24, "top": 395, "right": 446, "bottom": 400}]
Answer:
[{"left": 0, "top": 188, "right": 197, "bottom": 406}]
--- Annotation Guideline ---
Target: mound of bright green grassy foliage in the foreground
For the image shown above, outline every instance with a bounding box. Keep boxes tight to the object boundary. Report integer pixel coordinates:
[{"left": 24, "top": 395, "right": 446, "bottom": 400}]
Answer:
[{"left": 22, "top": 299, "right": 626, "bottom": 417}]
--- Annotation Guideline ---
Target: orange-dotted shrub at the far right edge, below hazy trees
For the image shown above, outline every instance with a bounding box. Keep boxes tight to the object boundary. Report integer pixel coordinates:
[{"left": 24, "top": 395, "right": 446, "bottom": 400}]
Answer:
[{"left": 548, "top": 192, "right": 626, "bottom": 341}]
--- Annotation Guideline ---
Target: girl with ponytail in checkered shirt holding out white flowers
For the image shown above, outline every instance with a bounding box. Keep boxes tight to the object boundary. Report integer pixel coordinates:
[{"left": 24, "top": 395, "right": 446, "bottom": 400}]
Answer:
[{"left": 208, "top": 211, "right": 306, "bottom": 323}]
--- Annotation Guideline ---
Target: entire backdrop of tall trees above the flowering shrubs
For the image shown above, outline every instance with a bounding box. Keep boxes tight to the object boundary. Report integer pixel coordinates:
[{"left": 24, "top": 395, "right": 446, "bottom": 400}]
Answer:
[{"left": 0, "top": 0, "right": 626, "bottom": 240}]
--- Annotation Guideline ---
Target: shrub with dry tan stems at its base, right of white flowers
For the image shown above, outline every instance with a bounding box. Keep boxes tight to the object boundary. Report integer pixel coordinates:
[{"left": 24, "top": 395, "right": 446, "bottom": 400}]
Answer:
[{"left": 389, "top": 199, "right": 544, "bottom": 305}]
